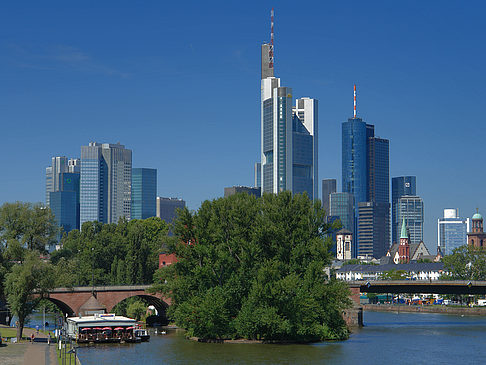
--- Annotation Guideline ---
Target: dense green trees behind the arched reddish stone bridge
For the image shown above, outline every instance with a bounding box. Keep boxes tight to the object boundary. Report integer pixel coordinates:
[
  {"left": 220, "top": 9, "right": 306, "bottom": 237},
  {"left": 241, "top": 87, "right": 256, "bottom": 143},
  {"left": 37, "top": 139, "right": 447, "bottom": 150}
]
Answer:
[{"left": 51, "top": 217, "right": 168, "bottom": 287}]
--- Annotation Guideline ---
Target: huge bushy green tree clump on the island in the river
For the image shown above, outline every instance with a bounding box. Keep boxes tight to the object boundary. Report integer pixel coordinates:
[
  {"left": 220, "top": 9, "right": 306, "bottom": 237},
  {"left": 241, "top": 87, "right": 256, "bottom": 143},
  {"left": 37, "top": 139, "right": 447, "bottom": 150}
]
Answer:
[{"left": 154, "top": 192, "right": 350, "bottom": 341}]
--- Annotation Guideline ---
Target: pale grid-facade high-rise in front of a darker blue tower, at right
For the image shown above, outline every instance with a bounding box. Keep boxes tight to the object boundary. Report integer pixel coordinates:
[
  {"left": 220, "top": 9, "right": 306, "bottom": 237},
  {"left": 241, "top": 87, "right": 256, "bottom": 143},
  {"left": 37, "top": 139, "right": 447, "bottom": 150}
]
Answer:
[{"left": 397, "top": 195, "right": 424, "bottom": 244}]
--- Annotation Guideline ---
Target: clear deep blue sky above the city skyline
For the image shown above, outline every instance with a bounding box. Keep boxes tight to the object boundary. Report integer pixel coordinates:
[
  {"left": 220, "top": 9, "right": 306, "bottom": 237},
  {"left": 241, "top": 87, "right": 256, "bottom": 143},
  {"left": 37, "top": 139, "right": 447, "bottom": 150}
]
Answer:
[{"left": 0, "top": 1, "right": 486, "bottom": 251}]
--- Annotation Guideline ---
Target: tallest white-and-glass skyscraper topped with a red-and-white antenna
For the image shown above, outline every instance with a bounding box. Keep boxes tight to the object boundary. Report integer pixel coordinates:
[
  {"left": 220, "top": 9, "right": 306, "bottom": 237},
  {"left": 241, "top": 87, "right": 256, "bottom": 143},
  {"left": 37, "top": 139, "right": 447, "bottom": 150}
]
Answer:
[{"left": 261, "top": 10, "right": 318, "bottom": 199}]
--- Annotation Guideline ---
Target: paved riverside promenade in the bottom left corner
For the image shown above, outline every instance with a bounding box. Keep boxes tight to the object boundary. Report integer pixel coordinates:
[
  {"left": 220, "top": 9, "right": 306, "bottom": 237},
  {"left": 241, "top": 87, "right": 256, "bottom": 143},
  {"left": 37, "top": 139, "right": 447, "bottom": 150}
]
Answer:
[{"left": 0, "top": 325, "right": 58, "bottom": 365}]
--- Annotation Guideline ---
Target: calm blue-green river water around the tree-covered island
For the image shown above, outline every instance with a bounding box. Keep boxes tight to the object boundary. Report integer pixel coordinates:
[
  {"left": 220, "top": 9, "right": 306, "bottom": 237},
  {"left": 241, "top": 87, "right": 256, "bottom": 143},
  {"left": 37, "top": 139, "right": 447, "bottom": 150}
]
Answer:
[{"left": 73, "top": 312, "right": 486, "bottom": 365}]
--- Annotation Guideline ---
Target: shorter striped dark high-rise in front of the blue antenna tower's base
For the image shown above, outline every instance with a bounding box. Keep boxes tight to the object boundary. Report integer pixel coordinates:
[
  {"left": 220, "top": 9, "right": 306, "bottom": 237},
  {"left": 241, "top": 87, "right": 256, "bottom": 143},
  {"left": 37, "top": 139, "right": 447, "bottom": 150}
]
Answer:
[{"left": 358, "top": 202, "right": 390, "bottom": 258}]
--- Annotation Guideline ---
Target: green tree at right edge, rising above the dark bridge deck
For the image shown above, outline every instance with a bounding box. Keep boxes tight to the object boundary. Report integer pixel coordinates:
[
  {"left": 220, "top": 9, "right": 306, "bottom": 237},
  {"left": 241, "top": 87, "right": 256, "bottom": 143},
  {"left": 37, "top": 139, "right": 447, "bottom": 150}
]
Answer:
[{"left": 441, "top": 245, "right": 486, "bottom": 280}]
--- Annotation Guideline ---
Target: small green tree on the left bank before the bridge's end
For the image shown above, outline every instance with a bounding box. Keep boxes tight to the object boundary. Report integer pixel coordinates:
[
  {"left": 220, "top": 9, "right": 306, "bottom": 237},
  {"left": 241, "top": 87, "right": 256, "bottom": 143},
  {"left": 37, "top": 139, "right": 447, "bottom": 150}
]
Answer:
[{"left": 5, "top": 252, "right": 54, "bottom": 341}]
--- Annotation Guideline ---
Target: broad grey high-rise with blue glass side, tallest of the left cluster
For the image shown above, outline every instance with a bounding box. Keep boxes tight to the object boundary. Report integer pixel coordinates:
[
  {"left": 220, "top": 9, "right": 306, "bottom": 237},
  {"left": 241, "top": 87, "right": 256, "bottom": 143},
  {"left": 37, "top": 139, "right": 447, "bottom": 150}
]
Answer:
[{"left": 80, "top": 142, "right": 132, "bottom": 225}]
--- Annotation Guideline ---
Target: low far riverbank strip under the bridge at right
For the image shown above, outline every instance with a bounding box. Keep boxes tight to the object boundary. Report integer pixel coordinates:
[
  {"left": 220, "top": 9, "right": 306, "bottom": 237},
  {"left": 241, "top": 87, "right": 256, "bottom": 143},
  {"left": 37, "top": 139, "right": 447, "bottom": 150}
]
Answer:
[{"left": 363, "top": 304, "right": 486, "bottom": 316}]
